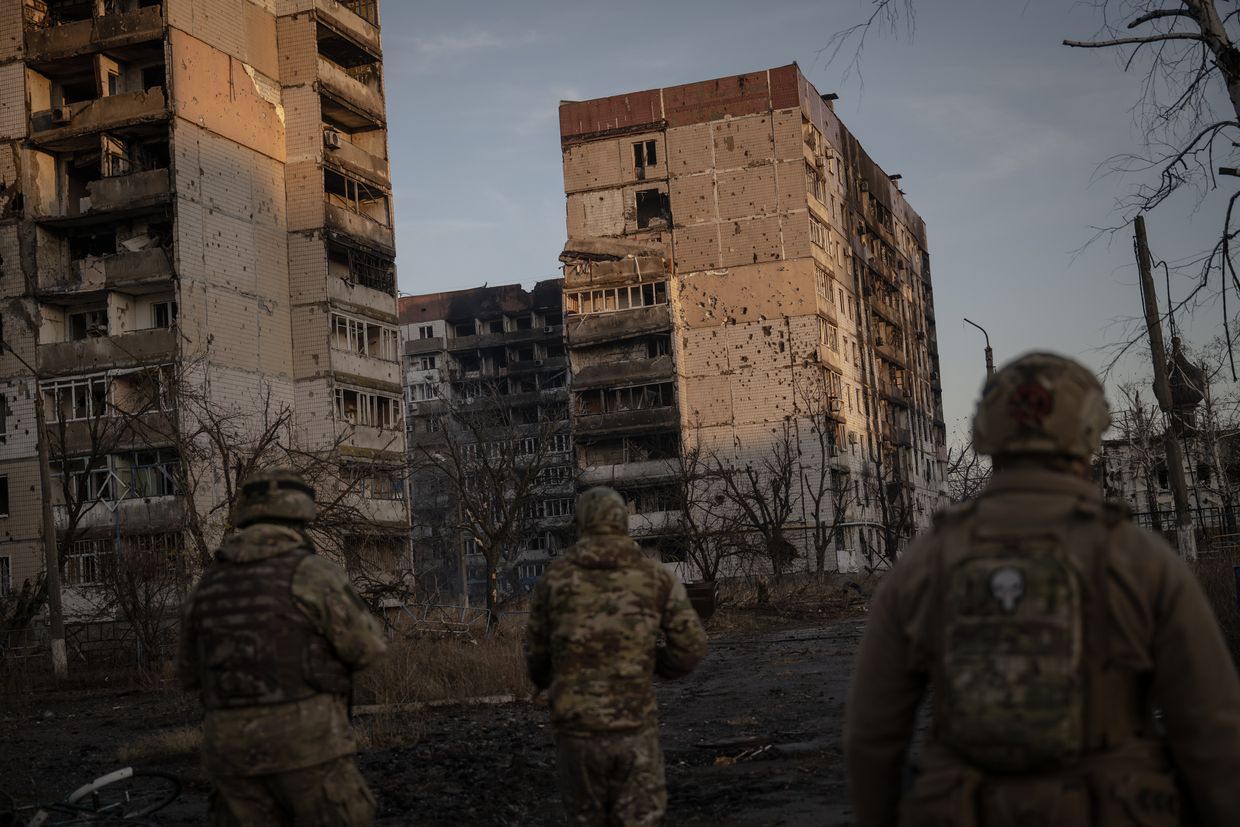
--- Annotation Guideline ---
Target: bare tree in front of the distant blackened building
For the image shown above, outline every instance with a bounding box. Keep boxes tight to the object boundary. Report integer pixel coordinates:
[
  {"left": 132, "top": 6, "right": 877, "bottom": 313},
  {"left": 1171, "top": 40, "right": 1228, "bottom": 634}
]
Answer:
[{"left": 413, "top": 383, "right": 568, "bottom": 621}]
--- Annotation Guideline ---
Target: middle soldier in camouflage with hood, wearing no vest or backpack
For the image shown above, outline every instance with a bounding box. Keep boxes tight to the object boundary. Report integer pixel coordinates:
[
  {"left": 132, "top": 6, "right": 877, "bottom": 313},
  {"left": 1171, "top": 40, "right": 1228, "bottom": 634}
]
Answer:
[{"left": 526, "top": 487, "right": 706, "bottom": 827}]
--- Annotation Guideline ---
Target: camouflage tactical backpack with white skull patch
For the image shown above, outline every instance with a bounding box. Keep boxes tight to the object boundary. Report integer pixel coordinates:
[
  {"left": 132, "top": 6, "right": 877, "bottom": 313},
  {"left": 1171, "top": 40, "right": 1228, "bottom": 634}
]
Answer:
[{"left": 934, "top": 508, "right": 1111, "bottom": 772}]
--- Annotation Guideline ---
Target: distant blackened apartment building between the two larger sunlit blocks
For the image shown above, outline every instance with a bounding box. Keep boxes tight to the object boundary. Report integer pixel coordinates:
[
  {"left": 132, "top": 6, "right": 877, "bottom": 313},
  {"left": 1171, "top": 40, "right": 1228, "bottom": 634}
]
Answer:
[{"left": 399, "top": 279, "right": 574, "bottom": 603}]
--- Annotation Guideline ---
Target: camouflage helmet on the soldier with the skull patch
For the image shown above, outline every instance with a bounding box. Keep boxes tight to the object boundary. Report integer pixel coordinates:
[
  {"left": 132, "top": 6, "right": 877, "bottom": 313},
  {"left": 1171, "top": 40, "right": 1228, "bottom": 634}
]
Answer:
[{"left": 973, "top": 353, "right": 1111, "bottom": 459}]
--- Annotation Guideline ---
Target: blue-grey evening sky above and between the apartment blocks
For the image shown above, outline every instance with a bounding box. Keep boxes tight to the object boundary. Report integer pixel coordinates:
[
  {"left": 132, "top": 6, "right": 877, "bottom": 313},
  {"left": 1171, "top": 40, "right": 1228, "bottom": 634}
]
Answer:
[{"left": 382, "top": 0, "right": 1235, "bottom": 438}]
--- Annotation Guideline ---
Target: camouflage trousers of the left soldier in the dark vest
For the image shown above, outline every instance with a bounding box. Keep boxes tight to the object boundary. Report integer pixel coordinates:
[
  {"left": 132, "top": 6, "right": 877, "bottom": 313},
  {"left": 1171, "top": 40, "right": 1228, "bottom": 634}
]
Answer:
[{"left": 210, "top": 755, "right": 374, "bottom": 827}]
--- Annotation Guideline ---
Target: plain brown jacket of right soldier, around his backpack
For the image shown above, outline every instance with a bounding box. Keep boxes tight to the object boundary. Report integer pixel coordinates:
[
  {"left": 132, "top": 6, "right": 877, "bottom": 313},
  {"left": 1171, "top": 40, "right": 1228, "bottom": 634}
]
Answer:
[{"left": 844, "top": 469, "right": 1240, "bottom": 827}]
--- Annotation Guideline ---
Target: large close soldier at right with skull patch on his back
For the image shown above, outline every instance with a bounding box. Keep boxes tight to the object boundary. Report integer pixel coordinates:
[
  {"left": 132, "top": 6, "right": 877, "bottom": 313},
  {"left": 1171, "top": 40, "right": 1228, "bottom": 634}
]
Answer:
[{"left": 844, "top": 353, "right": 1240, "bottom": 827}]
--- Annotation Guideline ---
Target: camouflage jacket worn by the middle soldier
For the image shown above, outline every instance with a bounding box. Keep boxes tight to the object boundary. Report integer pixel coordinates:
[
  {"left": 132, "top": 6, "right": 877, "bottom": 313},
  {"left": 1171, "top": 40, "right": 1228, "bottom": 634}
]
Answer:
[{"left": 526, "top": 523, "right": 706, "bottom": 734}]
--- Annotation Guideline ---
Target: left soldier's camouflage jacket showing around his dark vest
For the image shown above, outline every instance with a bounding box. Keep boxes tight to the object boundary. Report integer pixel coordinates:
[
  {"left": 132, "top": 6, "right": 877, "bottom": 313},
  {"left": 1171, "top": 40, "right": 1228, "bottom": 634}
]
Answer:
[{"left": 180, "top": 522, "right": 387, "bottom": 775}]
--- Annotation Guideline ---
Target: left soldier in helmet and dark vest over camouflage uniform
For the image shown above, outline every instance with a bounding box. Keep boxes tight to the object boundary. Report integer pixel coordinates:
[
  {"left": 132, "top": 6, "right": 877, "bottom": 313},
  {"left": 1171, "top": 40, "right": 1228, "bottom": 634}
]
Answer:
[{"left": 180, "top": 470, "right": 386, "bottom": 827}]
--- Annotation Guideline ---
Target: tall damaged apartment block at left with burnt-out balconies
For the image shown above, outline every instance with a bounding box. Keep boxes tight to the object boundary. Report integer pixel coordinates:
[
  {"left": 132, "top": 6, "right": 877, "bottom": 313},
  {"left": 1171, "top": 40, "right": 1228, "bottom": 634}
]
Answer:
[{"left": 0, "top": 0, "right": 408, "bottom": 607}]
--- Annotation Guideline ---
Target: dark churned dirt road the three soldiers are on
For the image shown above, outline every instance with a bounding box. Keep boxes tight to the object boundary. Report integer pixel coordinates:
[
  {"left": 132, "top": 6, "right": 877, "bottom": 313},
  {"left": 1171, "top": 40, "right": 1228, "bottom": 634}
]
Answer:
[{"left": 0, "top": 620, "right": 861, "bottom": 827}]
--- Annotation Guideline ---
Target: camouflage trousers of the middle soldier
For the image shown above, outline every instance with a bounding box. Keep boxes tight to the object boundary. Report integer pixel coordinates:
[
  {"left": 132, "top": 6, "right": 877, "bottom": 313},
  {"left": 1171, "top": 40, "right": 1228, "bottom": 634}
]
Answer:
[{"left": 556, "top": 725, "right": 667, "bottom": 827}]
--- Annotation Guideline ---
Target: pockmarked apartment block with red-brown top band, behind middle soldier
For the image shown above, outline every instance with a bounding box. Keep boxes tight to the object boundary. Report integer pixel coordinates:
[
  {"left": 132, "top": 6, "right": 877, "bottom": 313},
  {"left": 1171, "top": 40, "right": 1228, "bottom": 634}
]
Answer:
[{"left": 559, "top": 64, "right": 946, "bottom": 578}]
